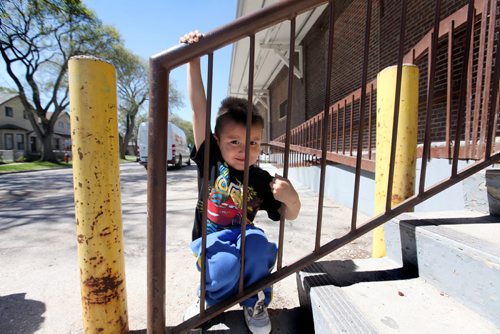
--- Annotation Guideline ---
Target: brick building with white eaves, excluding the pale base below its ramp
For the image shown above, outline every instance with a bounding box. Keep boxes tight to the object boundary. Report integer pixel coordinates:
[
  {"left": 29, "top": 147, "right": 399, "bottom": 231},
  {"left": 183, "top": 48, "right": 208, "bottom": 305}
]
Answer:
[{"left": 229, "top": 0, "right": 498, "bottom": 164}]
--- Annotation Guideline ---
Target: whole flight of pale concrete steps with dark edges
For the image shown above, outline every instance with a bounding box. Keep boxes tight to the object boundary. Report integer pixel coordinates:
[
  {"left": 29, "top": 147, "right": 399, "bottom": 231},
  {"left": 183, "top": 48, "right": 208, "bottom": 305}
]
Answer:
[{"left": 297, "top": 211, "right": 500, "bottom": 334}]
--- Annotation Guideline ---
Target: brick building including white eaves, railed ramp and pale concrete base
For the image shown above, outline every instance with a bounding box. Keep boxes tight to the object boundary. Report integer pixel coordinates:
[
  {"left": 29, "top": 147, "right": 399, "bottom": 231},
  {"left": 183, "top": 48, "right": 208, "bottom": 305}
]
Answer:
[{"left": 228, "top": 0, "right": 499, "bottom": 214}]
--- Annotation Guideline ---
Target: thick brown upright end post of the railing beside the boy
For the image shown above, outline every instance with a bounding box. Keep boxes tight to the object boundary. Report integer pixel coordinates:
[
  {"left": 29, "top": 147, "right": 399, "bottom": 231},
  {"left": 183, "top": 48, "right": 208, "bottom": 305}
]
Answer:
[{"left": 147, "top": 60, "right": 169, "bottom": 333}]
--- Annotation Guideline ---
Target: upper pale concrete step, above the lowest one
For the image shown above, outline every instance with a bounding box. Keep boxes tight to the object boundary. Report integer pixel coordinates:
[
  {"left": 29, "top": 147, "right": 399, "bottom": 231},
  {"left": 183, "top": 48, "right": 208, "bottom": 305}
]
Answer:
[{"left": 384, "top": 211, "right": 500, "bottom": 326}]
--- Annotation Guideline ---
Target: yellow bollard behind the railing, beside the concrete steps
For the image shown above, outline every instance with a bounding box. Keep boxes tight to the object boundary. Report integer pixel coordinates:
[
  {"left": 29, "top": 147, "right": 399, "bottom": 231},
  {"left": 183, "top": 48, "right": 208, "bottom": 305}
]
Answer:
[{"left": 372, "top": 64, "right": 419, "bottom": 258}]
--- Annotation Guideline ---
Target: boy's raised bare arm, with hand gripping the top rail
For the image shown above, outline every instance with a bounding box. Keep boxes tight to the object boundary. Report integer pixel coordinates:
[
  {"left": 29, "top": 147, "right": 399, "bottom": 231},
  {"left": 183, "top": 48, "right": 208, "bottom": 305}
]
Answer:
[{"left": 180, "top": 30, "right": 207, "bottom": 150}]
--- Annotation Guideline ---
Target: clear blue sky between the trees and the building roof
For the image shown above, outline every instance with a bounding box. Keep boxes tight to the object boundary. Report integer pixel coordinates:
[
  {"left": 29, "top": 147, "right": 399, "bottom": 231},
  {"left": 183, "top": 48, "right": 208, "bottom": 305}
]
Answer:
[{"left": 0, "top": 0, "right": 237, "bottom": 124}]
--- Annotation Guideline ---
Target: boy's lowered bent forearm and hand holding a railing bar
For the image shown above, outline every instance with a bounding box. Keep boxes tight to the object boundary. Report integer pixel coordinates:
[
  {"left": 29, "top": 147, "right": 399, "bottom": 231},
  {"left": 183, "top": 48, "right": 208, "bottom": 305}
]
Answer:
[{"left": 270, "top": 175, "right": 300, "bottom": 220}]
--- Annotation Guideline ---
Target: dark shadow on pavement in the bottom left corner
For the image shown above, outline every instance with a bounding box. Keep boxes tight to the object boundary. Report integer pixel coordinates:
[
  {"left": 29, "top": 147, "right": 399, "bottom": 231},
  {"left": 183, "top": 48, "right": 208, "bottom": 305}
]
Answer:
[{"left": 0, "top": 293, "right": 46, "bottom": 334}]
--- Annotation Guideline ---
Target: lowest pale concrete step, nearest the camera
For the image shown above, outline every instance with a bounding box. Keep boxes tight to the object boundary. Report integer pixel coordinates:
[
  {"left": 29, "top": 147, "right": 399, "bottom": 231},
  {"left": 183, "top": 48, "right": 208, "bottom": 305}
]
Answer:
[{"left": 297, "top": 259, "right": 500, "bottom": 334}]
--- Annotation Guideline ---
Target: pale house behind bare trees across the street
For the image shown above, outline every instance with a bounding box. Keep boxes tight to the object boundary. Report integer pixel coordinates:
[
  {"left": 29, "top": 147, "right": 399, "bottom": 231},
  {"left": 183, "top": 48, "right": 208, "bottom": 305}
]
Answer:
[{"left": 0, "top": 92, "right": 71, "bottom": 161}]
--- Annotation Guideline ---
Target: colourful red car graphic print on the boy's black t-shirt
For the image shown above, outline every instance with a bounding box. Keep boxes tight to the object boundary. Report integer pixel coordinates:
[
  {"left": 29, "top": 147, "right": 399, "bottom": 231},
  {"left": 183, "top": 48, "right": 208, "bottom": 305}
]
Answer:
[{"left": 207, "top": 163, "right": 261, "bottom": 227}]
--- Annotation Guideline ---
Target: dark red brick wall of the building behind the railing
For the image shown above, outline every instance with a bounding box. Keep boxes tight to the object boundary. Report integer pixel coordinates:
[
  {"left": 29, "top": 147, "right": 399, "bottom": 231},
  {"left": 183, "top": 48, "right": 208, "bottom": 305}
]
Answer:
[{"left": 271, "top": 0, "right": 498, "bottom": 154}]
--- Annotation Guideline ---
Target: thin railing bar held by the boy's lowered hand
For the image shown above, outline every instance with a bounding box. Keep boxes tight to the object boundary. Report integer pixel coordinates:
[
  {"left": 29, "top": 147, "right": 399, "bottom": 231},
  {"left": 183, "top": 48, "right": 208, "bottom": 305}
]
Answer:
[{"left": 277, "top": 17, "right": 295, "bottom": 270}]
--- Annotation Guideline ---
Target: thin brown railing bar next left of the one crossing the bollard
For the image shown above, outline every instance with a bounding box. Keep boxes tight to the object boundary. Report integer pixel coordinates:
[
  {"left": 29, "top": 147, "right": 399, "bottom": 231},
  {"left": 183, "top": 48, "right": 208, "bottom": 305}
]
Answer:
[{"left": 351, "top": 0, "right": 372, "bottom": 231}]
